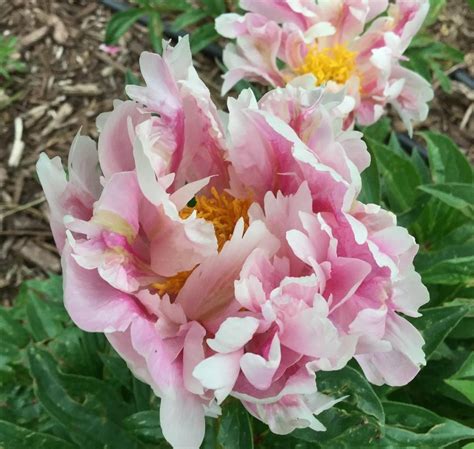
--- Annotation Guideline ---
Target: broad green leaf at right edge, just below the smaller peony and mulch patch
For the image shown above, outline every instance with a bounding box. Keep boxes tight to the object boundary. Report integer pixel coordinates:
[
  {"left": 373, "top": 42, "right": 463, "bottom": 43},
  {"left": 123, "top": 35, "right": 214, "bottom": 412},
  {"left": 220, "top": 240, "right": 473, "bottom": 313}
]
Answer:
[{"left": 420, "top": 131, "right": 473, "bottom": 184}]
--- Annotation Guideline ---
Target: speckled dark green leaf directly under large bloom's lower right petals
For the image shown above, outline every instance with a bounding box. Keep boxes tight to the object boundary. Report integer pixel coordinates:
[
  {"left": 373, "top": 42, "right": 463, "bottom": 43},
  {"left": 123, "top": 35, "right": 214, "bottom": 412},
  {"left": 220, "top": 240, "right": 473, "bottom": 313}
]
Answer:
[{"left": 316, "top": 366, "right": 385, "bottom": 423}]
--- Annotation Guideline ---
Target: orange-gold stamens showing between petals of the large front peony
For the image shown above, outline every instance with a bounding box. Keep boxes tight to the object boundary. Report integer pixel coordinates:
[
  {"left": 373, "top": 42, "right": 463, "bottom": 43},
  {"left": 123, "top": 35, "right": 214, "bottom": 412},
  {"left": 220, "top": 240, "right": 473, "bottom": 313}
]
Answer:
[{"left": 152, "top": 187, "right": 251, "bottom": 296}]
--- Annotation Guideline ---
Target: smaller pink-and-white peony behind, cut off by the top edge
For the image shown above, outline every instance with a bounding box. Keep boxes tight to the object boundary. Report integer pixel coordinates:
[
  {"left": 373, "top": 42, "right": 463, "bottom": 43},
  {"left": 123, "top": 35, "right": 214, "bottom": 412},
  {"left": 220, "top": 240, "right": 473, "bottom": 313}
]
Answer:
[{"left": 216, "top": 0, "right": 433, "bottom": 133}]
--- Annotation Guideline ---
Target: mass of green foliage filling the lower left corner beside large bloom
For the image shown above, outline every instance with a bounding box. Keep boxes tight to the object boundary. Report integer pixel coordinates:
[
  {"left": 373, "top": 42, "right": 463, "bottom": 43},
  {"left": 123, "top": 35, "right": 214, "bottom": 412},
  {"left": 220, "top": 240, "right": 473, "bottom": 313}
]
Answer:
[{"left": 0, "top": 276, "right": 165, "bottom": 449}]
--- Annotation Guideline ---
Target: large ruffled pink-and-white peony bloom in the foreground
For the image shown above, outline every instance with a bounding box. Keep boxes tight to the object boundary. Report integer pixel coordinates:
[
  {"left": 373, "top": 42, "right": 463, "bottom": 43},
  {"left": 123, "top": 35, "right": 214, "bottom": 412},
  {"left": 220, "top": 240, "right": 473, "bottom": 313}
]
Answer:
[{"left": 38, "top": 38, "right": 428, "bottom": 449}]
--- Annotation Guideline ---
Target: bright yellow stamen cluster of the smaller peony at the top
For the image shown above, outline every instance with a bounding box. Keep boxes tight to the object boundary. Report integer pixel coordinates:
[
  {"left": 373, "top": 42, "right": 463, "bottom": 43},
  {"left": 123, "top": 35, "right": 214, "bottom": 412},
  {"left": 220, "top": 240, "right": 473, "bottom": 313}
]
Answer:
[{"left": 295, "top": 44, "right": 357, "bottom": 86}]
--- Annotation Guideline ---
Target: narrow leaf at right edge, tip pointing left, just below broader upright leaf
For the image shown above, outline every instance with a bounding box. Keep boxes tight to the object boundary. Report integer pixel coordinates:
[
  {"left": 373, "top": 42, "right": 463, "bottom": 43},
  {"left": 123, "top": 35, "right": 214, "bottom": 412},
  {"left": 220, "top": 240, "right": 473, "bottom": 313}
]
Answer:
[{"left": 418, "top": 182, "right": 474, "bottom": 220}]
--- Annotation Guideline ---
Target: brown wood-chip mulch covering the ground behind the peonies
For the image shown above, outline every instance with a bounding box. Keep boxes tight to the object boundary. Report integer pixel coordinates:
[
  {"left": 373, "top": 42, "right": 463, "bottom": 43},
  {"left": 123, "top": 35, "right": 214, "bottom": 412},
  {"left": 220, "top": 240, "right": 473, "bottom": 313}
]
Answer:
[{"left": 0, "top": 0, "right": 474, "bottom": 303}]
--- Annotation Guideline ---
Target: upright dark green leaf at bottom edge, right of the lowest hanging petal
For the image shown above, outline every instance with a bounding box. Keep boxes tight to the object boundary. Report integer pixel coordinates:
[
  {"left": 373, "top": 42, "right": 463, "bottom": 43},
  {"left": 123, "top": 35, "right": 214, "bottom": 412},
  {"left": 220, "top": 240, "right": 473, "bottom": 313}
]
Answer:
[{"left": 217, "top": 401, "right": 254, "bottom": 449}]
